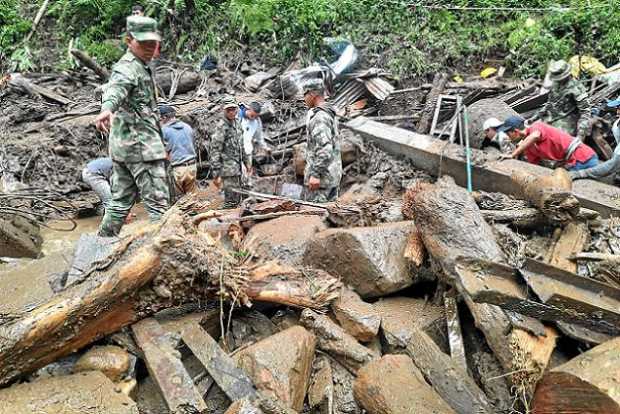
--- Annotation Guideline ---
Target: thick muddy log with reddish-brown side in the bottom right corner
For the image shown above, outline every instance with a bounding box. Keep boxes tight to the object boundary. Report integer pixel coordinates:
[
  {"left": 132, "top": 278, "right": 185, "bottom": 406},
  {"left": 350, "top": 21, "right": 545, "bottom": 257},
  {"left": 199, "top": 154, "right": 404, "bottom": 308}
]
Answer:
[{"left": 533, "top": 338, "right": 620, "bottom": 414}]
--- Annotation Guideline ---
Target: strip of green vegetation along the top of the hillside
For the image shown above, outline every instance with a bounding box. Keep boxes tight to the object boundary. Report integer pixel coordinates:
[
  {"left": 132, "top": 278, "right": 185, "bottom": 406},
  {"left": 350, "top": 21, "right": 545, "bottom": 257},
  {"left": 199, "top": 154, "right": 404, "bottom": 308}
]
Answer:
[{"left": 0, "top": 0, "right": 620, "bottom": 77}]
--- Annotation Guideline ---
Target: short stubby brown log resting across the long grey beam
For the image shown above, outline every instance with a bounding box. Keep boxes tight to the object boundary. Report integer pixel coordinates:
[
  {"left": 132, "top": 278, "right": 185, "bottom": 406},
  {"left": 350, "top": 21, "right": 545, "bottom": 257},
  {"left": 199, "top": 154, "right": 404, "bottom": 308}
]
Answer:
[{"left": 511, "top": 168, "right": 580, "bottom": 224}]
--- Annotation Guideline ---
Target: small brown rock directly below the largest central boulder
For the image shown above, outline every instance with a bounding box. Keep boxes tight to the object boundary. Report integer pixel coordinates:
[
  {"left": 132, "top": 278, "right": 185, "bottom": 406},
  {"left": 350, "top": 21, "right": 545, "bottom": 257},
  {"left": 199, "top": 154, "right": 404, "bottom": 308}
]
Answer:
[{"left": 332, "top": 289, "right": 381, "bottom": 342}]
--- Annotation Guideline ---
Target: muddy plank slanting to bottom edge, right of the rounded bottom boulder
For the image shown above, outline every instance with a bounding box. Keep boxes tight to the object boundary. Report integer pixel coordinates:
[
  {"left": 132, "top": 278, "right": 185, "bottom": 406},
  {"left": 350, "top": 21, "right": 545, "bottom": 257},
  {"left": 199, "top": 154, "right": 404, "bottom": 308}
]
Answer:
[{"left": 406, "top": 330, "right": 495, "bottom": 414}]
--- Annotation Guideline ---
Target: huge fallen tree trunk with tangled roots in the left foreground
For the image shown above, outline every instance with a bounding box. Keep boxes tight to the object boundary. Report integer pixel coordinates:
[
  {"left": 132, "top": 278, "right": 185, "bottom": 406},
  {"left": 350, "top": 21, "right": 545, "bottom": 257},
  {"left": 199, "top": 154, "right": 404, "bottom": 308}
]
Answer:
[{"left": 0, "top": 208, "right": 340, "bottom": 385}]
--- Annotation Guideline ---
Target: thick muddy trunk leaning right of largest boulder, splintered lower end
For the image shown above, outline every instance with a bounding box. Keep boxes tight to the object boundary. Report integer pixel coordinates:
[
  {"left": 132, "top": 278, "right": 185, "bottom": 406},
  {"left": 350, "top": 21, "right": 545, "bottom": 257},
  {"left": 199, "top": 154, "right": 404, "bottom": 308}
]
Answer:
[{"left": 403, "top": 177, "right": 556, "bottom": 396}]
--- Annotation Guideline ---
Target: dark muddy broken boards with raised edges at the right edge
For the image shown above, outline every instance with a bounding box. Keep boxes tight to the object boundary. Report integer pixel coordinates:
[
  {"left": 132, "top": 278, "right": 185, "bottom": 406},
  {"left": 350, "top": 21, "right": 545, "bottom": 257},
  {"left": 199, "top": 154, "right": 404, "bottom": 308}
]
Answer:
[{"left": 456, "top": 260, "right": 620, "bottom": 335}]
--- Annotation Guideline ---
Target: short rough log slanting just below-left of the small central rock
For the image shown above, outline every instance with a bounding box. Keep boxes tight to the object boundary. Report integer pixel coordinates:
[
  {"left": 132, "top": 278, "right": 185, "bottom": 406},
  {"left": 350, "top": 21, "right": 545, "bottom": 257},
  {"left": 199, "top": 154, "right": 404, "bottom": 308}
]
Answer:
[{"left": 300, "top": 309, "right": 380, "bottom": 374}]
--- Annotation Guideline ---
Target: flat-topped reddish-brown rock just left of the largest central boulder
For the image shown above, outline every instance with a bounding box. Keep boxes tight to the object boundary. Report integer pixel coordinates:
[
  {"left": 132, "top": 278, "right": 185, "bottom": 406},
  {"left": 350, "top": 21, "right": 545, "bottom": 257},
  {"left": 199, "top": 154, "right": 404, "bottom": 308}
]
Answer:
[{"left": 243, "top": 216, "right": 327, "bottom": 266}]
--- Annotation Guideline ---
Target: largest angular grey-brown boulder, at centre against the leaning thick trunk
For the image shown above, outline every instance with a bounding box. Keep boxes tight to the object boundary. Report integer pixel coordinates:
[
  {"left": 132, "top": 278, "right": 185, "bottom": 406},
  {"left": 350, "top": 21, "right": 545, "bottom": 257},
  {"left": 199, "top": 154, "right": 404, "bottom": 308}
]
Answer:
[{"left": 304, "top": 221, "right": 415, "bottom": 298}]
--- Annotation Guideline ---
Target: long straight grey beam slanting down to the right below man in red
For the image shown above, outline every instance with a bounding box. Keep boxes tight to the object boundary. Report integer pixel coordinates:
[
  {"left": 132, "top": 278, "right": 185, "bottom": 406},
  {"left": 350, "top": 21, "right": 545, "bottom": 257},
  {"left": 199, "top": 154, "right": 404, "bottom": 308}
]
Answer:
[{"left": 344, "top": 117, "right": 620, "bottom": 217}]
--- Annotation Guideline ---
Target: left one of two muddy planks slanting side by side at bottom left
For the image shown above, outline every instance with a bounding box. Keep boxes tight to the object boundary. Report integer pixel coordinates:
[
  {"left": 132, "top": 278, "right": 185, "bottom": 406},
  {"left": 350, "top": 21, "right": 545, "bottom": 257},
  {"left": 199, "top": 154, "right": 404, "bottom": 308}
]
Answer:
[{"left": 132, "top": 318, "right": 207, "bottom": 414}]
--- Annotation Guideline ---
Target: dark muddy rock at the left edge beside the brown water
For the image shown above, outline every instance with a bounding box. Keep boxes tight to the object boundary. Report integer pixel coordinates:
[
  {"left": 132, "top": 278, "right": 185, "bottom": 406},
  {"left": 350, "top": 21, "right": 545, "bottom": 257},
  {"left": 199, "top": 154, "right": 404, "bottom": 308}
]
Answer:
[{"left": 0, "top": 216, "right": 43, "bottom": 258}]
